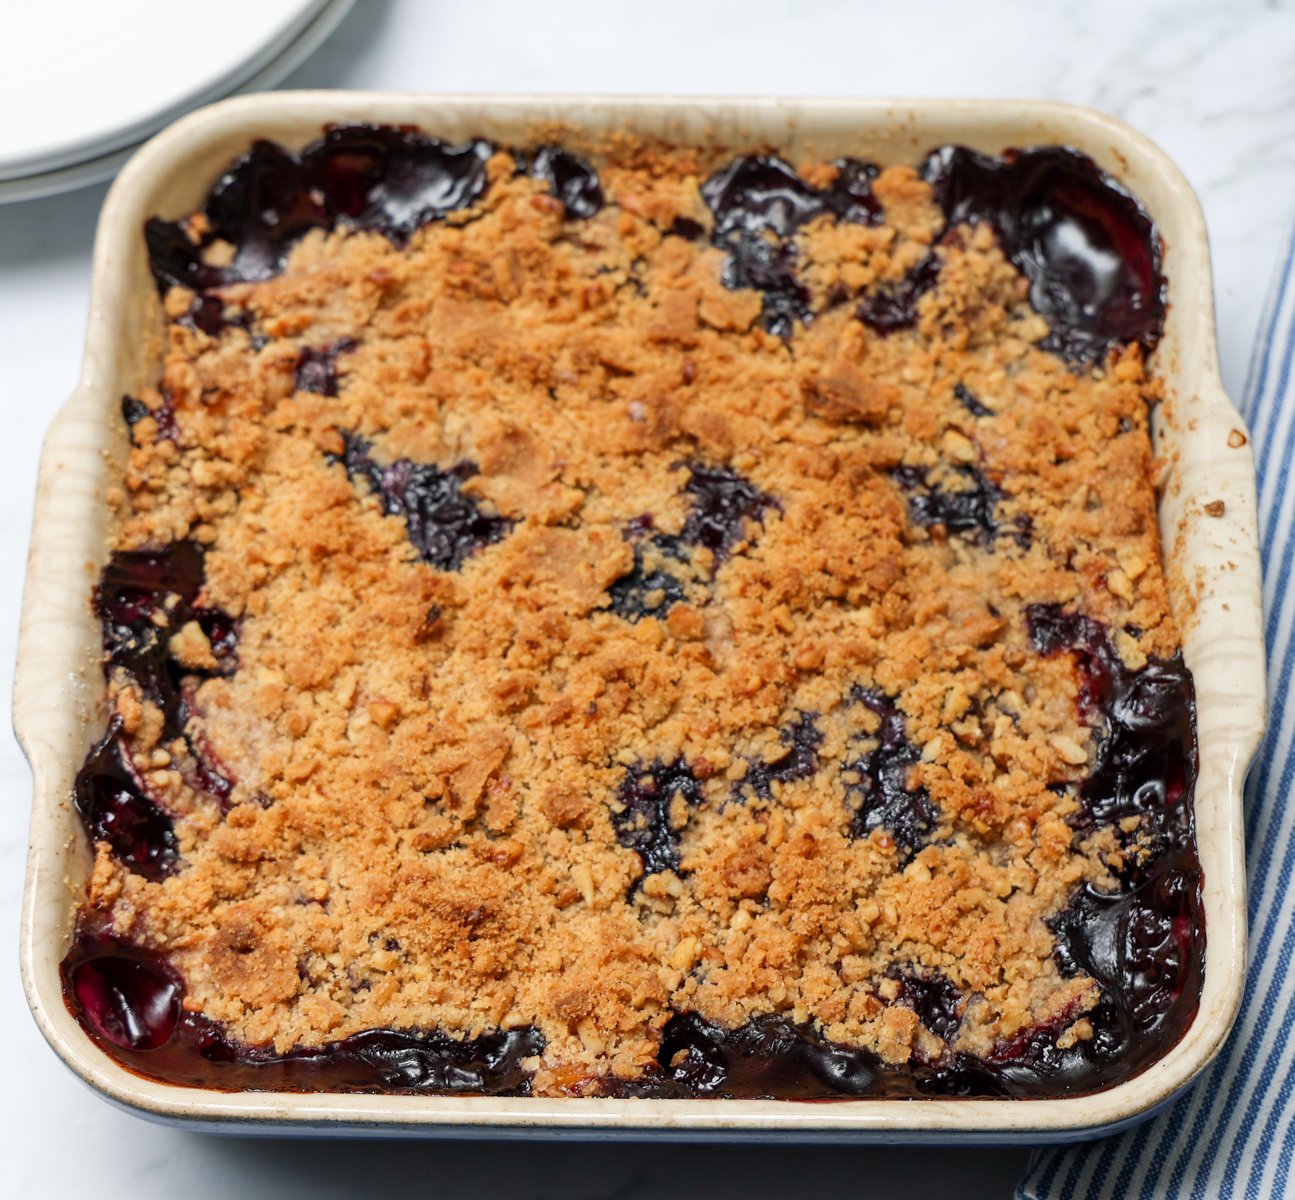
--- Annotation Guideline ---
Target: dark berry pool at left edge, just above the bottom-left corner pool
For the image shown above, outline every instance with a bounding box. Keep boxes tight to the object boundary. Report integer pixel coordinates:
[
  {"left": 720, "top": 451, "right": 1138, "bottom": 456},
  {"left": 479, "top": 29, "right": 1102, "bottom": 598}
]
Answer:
[{"left": 73, "top": 720, "right": 180, "bottom": 880}]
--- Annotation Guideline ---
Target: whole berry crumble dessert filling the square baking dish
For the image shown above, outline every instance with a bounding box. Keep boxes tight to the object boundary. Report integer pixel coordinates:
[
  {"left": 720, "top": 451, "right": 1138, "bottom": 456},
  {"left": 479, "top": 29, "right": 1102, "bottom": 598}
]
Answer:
[{"left": 63, "top": 127, "right": 1203, "bottom": 1098}]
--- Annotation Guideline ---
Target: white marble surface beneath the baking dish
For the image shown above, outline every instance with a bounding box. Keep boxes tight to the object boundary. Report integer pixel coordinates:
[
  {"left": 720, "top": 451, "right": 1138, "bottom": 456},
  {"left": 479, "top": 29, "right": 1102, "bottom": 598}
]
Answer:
[{"left": 0, "top": 0, "right": 1295, "bottom": 1200}]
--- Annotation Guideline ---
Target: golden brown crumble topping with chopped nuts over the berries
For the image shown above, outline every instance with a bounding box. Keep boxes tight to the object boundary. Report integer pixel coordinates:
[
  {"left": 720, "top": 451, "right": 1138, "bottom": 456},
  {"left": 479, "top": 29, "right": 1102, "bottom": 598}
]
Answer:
[{"left": 89, "top": 135, "right": 1178, "bottom": 1094}]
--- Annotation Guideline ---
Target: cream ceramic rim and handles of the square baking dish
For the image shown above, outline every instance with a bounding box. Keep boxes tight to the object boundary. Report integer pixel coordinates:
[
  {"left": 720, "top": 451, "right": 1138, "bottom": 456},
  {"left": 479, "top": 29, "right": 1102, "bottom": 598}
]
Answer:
[{"left": 14, "top": 92, "right": 1264, "bottom": 1142}]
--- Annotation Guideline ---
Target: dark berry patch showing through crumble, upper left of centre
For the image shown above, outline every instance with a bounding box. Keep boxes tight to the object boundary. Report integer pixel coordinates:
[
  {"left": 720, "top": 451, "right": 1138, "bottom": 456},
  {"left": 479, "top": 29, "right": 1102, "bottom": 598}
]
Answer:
[{"left": 329, "top": 432, "right": 513, "bottom": 571}]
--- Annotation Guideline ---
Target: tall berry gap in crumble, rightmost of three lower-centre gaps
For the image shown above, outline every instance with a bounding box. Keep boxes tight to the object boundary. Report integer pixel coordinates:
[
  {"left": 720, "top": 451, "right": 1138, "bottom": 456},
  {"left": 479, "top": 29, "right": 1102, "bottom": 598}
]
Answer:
[{"left": 844, "top": 687, "right": 940, "bottom": 863}]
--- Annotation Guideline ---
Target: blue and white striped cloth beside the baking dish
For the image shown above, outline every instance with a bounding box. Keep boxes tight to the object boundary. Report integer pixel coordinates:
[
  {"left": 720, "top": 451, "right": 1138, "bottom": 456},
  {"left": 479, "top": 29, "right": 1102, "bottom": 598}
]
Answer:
[{"left": 1017, "top": 225, "right": 1295, "bottom": 1200}]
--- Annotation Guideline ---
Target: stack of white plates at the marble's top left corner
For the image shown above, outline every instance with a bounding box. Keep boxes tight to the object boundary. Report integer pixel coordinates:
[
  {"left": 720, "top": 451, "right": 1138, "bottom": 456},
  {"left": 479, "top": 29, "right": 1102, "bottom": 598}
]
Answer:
[{"left": 0, "top": 0, "right": 352, "bottom": 203}]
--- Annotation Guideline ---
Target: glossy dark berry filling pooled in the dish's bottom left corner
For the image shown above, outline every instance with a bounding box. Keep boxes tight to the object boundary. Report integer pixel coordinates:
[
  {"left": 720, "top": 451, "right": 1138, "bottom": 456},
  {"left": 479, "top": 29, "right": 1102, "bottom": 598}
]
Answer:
[{"left": 62, "top": 932, "right": 544, "bottom": 1095}]
